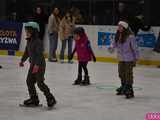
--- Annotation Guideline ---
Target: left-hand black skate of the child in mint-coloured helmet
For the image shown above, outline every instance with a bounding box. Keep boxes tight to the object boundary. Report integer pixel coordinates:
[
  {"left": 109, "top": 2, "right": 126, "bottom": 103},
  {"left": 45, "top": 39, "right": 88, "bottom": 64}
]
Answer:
[{"left": 23, "top": 96, "right": 39, "bottom": 106}]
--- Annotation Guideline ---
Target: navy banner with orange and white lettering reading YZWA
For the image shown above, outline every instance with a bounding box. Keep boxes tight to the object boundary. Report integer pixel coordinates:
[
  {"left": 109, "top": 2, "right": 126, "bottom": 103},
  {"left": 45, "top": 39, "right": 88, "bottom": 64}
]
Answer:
[{"left": 0, "top": 21, "right": 22, "bottom": 50}]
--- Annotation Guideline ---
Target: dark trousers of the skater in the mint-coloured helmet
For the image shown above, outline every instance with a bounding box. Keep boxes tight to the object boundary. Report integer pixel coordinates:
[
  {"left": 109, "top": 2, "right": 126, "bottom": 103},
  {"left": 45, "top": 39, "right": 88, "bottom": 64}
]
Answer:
[{"left": 26, "top": 65, "right": 50, "bottom": 97}]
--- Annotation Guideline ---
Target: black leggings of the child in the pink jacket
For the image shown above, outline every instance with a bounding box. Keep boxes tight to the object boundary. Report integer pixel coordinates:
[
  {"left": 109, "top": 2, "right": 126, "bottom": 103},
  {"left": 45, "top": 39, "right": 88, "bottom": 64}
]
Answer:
[{"left": 78, "top": 62, "right": 88, "bottom": 76}]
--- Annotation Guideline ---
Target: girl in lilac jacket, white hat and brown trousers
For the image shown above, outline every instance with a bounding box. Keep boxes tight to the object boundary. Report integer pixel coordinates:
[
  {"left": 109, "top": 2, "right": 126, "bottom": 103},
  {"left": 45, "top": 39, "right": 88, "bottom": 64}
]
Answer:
[{"left": 109, "top": 21, "right": 139, "bottom": 98}]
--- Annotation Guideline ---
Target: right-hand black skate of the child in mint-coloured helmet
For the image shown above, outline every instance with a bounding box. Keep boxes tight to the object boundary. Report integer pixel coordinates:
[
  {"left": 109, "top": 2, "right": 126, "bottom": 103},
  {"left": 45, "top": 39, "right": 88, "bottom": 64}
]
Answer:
[{"left": 46, "top": 94, "right": 57, "bottom": 108}]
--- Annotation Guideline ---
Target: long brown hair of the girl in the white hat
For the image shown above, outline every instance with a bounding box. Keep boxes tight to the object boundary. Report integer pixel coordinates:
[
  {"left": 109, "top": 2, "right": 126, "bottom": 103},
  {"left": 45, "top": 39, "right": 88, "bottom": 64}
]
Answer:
[{"left": 115, "top": 28, "right": 132, "bottom": 44}]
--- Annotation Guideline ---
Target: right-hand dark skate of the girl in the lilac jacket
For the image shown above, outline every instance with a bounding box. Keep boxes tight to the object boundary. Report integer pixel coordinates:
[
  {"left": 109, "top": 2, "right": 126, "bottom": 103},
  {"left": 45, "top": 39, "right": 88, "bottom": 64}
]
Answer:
[{"left": 125, "top": 85, "right": 134, "bottom": 99}]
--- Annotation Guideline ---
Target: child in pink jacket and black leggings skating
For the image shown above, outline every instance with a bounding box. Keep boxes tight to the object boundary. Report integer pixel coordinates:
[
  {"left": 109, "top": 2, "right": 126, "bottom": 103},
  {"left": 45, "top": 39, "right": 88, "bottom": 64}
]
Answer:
[{"left": 70, "top": 27, "right": 96, "bottom": 85}]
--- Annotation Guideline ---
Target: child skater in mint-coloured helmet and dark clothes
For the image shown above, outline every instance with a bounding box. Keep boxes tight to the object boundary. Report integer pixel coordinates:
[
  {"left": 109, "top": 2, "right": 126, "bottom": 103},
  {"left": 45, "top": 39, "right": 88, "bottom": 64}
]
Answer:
[{"left": 19, "top": 22, "right": 56, "bottom": 107}]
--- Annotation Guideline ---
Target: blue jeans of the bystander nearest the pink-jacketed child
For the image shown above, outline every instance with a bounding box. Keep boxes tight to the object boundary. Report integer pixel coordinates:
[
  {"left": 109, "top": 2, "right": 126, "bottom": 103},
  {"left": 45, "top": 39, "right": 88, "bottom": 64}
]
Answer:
[{"left": 60, "top": 37, "right": 73, "bottom": 60}]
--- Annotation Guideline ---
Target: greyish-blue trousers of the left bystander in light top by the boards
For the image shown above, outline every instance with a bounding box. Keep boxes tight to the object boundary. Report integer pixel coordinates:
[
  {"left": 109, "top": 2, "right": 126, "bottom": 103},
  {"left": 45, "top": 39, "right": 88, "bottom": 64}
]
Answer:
[{"left": 48, "top": 32, "right": 58, "bottom": 60}]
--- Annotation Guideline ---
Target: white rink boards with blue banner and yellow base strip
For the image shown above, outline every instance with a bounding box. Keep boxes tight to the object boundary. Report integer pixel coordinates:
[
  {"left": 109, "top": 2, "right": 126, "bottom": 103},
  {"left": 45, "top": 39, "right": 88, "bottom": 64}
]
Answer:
[{"left": 0, "top": 21, "right": 160, "bottom": 65}]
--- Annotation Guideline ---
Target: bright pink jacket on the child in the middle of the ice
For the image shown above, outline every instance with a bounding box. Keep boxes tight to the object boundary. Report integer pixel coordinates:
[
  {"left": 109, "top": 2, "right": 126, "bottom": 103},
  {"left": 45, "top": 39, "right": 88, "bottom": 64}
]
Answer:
[{"left": 75, "top": 34, "right": 92, "bottom": 62}]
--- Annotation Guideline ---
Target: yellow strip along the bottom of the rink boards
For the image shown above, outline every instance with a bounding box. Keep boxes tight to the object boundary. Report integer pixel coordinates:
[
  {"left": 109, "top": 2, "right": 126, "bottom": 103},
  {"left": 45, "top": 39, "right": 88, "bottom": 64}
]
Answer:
[{"left": 0, "top": 50, "right": 160, "bottom": 65}]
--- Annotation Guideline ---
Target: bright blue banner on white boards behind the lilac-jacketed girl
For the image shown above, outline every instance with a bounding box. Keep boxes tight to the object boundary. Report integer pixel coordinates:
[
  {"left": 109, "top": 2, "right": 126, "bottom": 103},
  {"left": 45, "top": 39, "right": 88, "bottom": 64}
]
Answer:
[{"left": 97, "top": 32, "right": 156, "bottom": 48}]
